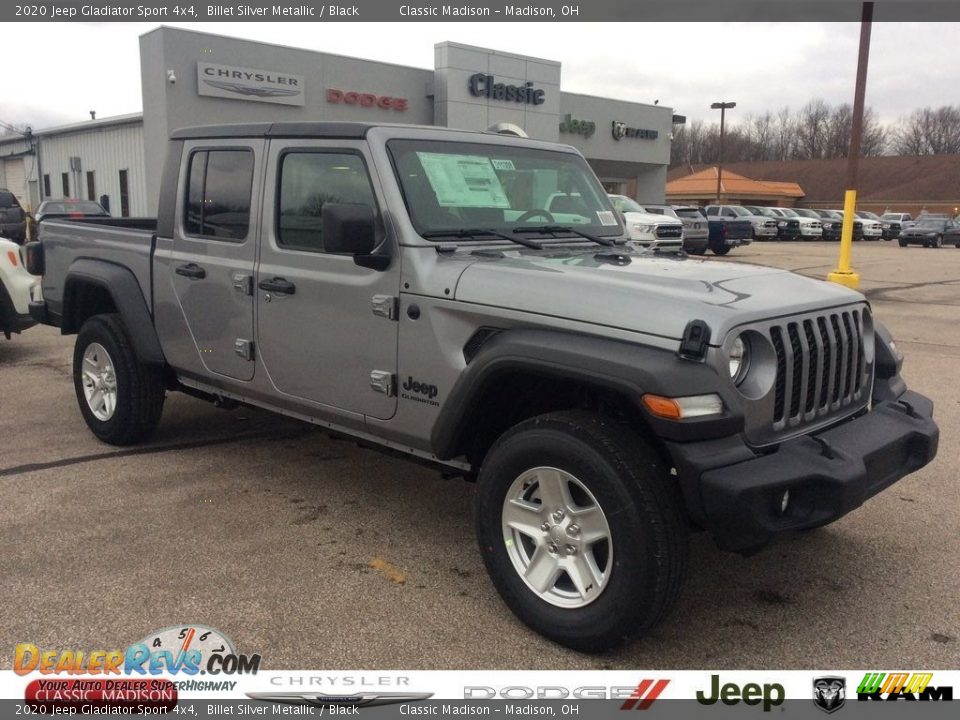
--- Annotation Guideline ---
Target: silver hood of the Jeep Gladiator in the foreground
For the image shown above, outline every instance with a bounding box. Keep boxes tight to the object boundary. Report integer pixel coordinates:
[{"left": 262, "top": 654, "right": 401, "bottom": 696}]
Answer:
[{"left": 454, "top": 248, "right": 863, "bottom": 344}]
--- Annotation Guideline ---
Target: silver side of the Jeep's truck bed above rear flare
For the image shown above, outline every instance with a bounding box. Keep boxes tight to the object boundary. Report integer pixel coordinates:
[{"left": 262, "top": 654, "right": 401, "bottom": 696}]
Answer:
[{"left": 40, "top": 218, "right": 157, "bottom": 314}]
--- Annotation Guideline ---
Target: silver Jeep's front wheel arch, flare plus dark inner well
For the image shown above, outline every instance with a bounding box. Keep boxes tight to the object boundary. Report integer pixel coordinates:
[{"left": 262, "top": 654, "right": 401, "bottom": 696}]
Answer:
[{"left": 431, "top": 329, "right": 742, "bottom": 463}]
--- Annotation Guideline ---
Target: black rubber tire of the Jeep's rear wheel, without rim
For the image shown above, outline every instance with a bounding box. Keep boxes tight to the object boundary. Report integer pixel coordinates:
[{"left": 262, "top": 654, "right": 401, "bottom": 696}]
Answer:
[{"left": 73, "top": 314, "right": 166, "bottom": 445}]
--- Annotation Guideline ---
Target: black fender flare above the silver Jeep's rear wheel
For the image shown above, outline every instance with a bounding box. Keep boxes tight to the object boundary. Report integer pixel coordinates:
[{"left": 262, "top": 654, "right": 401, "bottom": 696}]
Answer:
[{"left": 61, "top": 258, "right": 166, "bottom": 365}]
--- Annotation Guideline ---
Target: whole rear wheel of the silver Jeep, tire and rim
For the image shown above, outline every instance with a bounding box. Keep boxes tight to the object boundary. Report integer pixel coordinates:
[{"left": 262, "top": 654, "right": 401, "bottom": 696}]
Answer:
[{"left": 73, "top": 314, "right": 166, "bottom": 445}]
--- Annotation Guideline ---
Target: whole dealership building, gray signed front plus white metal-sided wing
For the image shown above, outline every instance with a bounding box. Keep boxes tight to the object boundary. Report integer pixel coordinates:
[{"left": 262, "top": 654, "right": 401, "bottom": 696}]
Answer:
[{"left": 0, "top": 27, "right": 678, "bottom": 216}]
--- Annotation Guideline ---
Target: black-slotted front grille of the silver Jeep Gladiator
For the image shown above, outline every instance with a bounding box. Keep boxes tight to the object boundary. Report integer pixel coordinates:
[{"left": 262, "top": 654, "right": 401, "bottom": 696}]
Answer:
[{"left": 769, "top": 308, "right": 870, "bottom": 432}]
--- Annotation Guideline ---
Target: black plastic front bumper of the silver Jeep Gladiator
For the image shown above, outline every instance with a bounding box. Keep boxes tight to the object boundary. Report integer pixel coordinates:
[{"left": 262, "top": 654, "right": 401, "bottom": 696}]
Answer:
[{"left": 669, "top": 391, "right": 940, "bottom": 552}]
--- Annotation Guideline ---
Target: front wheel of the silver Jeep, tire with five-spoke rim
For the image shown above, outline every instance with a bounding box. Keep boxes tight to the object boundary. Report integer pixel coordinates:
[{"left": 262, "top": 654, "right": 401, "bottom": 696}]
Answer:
[{"left": 476, "top": 412, "right": 687, "bottom": 652}]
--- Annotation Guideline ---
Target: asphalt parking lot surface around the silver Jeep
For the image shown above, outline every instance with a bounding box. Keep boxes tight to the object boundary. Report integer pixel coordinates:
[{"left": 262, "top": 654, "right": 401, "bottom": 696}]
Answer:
[{"left": 0, "top": 242, "right": 960, "bottom": 669}]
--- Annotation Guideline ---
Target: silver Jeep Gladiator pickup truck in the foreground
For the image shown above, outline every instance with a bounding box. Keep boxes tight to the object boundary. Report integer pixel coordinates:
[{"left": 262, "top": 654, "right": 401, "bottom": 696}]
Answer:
[{"left": 27, "top": 123, "right": 938, "bottom": 651}]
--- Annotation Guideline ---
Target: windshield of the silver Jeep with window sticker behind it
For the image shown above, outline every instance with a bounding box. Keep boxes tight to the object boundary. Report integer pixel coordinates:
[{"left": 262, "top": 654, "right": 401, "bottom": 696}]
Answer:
[{"left": 387, "top": 140, "right": 623, "bottom": 236}]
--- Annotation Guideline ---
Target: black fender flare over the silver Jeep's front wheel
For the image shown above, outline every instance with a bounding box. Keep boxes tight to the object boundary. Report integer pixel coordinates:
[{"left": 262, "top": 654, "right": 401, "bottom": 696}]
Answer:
[{"left": 430, "top": 329, "right": 743, "bottom": 460}]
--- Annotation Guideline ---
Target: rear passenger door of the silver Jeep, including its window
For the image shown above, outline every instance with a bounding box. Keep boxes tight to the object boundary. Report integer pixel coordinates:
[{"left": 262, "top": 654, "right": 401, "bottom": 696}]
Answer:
[{"left": 166, "top": 138, "right": 265, "bottom": 380}]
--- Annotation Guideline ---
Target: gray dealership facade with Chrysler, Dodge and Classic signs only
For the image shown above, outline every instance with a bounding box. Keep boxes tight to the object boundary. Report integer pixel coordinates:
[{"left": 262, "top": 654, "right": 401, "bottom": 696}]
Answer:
[{"left": 140, "top": 27, "right": 673, "bottom": 212}]
